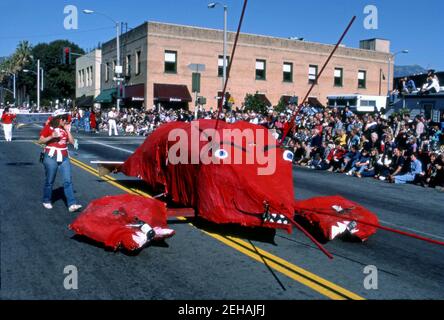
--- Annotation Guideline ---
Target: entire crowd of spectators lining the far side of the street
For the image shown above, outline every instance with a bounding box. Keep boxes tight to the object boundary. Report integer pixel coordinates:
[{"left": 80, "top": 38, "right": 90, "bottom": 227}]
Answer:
[{"left": 67, "top": 104, "right": 444, "bottom": 187}]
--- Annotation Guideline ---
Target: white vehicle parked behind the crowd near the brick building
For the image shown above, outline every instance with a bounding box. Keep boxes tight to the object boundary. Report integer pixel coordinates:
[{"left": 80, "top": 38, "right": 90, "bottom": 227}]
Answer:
[{"left": 327, "top": 94, "right": 387, "bottom": 112}]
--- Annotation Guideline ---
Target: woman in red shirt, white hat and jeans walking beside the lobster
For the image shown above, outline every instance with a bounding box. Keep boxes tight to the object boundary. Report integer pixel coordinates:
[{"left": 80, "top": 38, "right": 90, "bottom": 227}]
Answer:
[{"left": 38, "top": 111, "right": 82, "bottom": 212}]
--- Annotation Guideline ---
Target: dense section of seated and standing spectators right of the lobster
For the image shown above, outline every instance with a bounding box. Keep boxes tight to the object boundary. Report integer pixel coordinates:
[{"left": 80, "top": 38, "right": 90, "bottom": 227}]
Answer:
[{"left": 286, "top": 107, "right": 444, "bottom": 188}]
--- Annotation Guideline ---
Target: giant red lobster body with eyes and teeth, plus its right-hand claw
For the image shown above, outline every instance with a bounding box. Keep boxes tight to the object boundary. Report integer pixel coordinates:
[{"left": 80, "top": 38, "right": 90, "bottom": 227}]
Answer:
[{"left": 120, "top": 120, "right": 377, "bottom": 240}]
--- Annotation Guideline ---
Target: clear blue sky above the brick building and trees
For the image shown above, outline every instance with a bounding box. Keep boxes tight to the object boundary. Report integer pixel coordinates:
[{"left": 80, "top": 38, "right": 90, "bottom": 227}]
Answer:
[{"left": 0, "top": 0, "right": 444, "bottom": 70}]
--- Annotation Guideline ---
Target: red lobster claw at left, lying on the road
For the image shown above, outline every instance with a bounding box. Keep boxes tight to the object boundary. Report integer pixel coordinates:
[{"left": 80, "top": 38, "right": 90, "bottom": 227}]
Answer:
[{"left": 69, "top": 194, "right": 174, "bottom": 250}]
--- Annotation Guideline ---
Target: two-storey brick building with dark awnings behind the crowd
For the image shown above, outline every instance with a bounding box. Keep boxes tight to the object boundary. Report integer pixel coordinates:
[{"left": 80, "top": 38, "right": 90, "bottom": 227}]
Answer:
[{"left": 95, "top": 22, "right": 393, "bottom": 109}]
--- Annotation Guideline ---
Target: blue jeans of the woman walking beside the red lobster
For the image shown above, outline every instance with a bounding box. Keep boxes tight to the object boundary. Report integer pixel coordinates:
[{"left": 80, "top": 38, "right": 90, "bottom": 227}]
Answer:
[{"left": 43, "top": 153, "right": 76, "bottom": 207}]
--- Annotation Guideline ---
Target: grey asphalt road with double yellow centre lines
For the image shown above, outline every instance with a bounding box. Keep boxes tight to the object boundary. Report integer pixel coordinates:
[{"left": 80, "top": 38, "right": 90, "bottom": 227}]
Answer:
[{"left": 0, "top": 126, "right": 444, "bottom": 300}]
